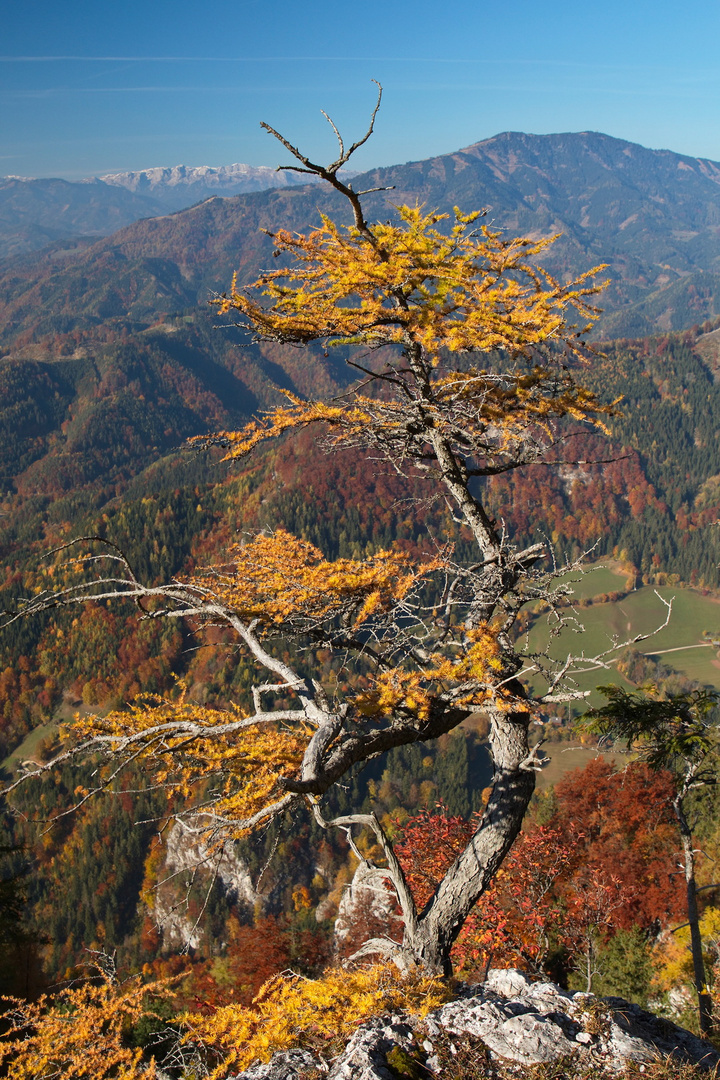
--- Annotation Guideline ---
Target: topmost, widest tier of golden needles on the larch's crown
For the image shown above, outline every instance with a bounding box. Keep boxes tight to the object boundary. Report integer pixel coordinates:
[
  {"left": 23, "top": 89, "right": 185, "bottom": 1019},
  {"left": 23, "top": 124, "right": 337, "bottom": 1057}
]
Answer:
[{"left": 214, "top": 206, "right": 604, "bottom": 357}]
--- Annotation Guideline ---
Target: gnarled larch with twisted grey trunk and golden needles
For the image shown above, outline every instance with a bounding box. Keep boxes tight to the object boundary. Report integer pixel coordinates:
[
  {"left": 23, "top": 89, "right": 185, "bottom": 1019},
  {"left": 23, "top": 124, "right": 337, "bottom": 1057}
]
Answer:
[{"left": 0, "top": 90, "right": 643, "bottom": 974}]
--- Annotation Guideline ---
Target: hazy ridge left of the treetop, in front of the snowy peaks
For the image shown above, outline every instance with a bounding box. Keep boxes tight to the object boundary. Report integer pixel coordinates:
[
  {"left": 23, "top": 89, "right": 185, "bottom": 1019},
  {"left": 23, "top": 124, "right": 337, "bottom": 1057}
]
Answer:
[{"left": 0, "top": 188, "right": 340, "bottom": 352}]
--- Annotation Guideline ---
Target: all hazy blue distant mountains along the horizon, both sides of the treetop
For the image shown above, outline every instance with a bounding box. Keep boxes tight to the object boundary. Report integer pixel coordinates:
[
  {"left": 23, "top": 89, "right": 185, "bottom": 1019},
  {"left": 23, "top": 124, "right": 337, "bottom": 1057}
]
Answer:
[{"left": 0, "top": 132, "right": 720, "bottom": 346}]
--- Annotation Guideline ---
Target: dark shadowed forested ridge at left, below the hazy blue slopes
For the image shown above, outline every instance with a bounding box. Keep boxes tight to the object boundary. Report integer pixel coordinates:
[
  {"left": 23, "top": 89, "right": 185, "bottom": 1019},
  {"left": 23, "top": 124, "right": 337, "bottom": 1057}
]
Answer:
[{"left": 0, "top": 318, "right": 351, "bottom": 520}]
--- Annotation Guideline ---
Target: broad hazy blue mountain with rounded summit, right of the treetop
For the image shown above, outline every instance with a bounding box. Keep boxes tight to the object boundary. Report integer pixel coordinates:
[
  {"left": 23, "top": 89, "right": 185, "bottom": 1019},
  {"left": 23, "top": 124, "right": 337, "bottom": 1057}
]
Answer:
[{"left": 364, "top": 132, "right": 720, "bottom": 336}]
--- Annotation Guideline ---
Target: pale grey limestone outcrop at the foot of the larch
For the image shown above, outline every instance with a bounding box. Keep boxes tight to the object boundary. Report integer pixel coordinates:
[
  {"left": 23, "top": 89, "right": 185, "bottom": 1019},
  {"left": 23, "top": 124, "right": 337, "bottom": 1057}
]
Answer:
[{"left": 239, "top": 971, "right": 720, "bottom": 1080}]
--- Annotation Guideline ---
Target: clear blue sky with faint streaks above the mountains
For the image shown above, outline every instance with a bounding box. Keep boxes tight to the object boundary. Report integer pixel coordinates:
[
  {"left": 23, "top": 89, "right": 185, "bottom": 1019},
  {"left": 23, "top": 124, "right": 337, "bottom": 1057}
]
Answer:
[{"left": 0, "top": 0, "right": 720, "bottom": 179}]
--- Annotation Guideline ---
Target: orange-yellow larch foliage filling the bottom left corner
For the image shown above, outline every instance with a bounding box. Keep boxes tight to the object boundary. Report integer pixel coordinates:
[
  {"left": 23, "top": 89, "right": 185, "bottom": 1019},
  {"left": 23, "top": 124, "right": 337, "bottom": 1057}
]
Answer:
[{"left": 0, "top": 980, "right": 171, "bottom": 1080}]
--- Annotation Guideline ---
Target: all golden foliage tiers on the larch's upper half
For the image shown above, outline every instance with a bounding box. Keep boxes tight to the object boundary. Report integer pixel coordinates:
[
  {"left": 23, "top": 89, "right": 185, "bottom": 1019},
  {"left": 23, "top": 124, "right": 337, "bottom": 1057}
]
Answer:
[{"left": 201, "top": 206, "right": 612, "bottom": 466}]
